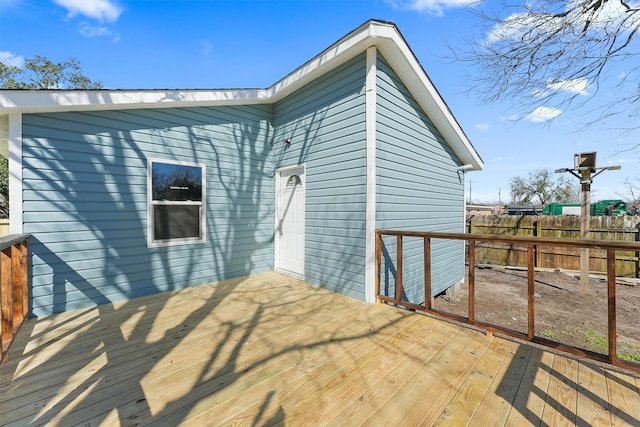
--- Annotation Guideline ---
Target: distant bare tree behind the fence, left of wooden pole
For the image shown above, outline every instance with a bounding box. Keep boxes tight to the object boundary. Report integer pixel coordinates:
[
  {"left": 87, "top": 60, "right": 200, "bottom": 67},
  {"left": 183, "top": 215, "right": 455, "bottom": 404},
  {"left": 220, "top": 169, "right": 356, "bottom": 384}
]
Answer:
[{"left": 509, "top": 169, "right": 580, "bottom": 206}]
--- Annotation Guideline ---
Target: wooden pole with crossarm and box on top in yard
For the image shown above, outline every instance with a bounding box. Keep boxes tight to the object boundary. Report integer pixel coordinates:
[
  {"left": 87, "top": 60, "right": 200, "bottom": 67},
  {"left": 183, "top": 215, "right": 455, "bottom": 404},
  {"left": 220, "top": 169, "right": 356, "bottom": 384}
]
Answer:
[{"left": 556, "top": 151, "right": 620, "bottom": 294}]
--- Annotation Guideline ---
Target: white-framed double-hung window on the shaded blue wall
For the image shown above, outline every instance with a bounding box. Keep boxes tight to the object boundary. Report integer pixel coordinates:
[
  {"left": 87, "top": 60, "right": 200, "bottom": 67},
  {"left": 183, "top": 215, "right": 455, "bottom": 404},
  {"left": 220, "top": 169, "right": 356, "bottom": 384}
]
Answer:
[{"left": 147, "top": 159, "right": 206, "bottom": 247}]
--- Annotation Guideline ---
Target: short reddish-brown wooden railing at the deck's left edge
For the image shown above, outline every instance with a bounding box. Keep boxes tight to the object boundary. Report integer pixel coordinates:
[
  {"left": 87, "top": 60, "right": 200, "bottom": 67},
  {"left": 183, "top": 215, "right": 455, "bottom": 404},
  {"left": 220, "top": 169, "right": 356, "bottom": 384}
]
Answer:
[{"left": 0, "top": 234, "right": 29, "bottom": 361}]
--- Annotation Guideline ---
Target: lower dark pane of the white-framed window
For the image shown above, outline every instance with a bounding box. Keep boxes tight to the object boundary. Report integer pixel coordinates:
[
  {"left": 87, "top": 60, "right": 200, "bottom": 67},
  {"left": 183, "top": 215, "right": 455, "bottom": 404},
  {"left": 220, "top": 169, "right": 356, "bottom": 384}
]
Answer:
[{"left": 153, "top": 205, "right": 201, "bottom": 240}]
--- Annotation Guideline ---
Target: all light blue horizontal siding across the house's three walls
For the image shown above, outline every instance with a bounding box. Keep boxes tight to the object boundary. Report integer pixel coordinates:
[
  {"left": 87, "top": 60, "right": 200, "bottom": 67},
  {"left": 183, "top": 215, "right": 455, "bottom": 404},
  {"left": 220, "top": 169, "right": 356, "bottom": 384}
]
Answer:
[{"left": 17, "top": 53, "right": 472, "bottom": 316}]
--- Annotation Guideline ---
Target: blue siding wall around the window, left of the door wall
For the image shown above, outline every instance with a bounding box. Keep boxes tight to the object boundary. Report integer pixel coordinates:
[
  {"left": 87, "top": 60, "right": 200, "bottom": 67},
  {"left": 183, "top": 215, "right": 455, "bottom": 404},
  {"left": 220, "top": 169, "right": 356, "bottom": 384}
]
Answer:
[{"left": 23, "top": 106, "right": 274, "bottom": 316}]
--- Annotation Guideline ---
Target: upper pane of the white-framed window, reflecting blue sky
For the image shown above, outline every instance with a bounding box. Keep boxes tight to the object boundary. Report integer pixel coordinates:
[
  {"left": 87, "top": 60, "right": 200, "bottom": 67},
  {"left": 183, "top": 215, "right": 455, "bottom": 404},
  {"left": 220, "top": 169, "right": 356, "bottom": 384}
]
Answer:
[{"left": 151, "top": 162, "right": 202, "bottom": 201}]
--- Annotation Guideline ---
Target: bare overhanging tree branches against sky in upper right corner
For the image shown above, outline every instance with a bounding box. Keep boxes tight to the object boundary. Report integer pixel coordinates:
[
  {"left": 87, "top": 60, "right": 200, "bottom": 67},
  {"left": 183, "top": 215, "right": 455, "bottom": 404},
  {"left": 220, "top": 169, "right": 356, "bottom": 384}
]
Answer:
[{"left": 455, "top": 0, "right": 640, "bottom": 136}]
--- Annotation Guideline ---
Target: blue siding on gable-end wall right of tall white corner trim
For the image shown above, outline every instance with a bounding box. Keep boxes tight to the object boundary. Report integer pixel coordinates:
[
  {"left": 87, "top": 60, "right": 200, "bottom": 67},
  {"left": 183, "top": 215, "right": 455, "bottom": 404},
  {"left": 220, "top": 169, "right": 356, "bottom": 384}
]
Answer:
[{"left": 376, "top": 57, "right": 464, "bottom": 303}]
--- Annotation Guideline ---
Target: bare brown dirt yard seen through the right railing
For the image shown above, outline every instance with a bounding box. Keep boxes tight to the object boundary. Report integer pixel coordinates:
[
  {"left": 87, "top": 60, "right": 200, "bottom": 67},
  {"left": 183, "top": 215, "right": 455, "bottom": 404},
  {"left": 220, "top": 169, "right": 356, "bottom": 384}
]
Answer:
[{"left": 434, "top": 266, "right": 640, "bottom": 363}]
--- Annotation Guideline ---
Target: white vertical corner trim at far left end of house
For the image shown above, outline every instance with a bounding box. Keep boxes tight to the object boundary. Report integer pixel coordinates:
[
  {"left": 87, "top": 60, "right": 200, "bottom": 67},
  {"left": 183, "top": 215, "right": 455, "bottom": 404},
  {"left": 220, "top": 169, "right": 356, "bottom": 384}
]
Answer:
[{"left": 9, "top": 113, "right": 23, "bottom": 234}]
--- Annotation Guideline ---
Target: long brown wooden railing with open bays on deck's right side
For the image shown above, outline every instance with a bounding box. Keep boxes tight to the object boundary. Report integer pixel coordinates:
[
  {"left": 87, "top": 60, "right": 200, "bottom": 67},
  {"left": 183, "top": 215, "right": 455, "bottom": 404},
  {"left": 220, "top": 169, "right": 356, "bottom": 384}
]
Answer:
[{"left": 375, "top": 230, "right": 640, "bottom": 372}]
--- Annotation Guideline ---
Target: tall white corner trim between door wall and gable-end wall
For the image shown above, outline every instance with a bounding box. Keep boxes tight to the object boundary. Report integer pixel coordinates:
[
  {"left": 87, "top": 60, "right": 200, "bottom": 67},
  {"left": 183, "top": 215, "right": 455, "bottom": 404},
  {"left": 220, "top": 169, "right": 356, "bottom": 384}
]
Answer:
[{"left": 364, "top": 46, "right": 378, "bottom": 303}]
